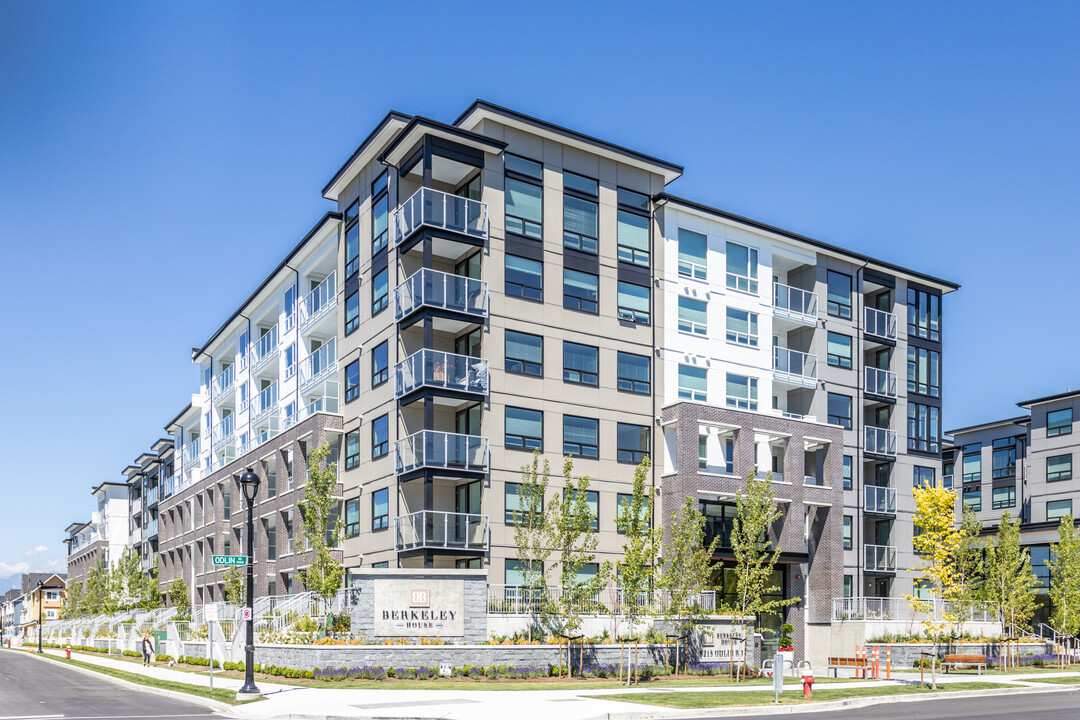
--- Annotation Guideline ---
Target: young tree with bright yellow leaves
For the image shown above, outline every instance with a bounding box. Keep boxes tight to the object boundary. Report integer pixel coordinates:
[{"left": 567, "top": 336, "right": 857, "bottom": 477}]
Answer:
[{"left": 983, "top": 511, "right": 1039, "bottom": 662}]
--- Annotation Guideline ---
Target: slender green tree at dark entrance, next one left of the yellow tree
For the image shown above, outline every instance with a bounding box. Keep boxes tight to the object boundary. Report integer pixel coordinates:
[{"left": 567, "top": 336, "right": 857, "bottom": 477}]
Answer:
[{"left": 731, "top": 470, "right": 799, "bottom": 678}]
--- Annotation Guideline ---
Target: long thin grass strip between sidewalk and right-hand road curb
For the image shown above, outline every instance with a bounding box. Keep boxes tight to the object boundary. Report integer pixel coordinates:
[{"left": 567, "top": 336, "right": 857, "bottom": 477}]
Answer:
[{"left": 591, "top": 682, "right": 1001, "bottom": 710}]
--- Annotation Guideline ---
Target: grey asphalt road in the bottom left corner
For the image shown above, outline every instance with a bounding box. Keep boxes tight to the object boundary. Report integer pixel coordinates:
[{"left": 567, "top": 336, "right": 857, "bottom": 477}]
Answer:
[{"left": 0, "top": 650, "right": 220, "bottom": 720}]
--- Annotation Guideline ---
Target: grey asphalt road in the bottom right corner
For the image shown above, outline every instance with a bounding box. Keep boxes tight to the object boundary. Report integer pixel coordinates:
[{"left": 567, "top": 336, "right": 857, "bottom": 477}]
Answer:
[{"left": 708, "top": 689, "right": 1080, "bottom": 720}]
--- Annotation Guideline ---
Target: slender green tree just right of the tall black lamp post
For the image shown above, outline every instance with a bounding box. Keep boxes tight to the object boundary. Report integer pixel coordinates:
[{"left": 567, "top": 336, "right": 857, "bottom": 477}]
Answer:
[{"left": 297, "top": 443, "right": 345, "bottom": 601}]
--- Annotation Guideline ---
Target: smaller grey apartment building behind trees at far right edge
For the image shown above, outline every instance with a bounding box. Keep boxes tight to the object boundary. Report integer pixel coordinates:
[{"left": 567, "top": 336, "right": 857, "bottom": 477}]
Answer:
[{"left": 944, "top": 391, "right": 1080, "bottom": 622}]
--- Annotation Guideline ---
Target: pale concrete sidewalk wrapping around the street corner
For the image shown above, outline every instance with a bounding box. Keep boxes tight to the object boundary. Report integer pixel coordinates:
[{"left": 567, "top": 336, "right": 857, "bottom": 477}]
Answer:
[{"left": 31, "top": 650, "right": 1080, "bottom": 720}]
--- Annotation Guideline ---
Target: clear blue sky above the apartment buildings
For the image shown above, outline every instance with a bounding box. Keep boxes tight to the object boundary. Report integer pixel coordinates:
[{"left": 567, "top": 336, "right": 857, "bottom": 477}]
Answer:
[{"left": 0, "top": 1, "right": 1080, "bottom": 578}]
